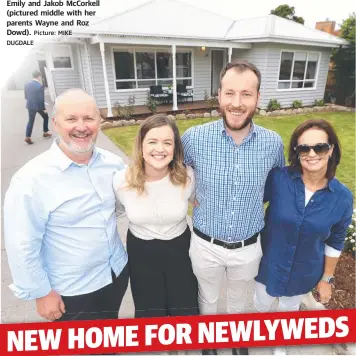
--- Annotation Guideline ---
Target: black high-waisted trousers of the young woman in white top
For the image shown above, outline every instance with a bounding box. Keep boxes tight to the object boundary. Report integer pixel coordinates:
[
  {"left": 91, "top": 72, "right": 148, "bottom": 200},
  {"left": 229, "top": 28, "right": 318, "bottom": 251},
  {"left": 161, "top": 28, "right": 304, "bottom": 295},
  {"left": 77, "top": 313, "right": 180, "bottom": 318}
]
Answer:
[{"left": 127, "top": 228, "right": 199, "bottom": 318}]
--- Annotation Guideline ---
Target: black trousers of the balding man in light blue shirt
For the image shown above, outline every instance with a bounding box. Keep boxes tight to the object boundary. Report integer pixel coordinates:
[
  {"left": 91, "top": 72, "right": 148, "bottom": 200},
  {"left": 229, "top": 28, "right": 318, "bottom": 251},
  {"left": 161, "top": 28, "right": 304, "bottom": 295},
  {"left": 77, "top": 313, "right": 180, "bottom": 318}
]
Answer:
[{"left": 57, "top": 265, "right": 129, "bottom": 321}]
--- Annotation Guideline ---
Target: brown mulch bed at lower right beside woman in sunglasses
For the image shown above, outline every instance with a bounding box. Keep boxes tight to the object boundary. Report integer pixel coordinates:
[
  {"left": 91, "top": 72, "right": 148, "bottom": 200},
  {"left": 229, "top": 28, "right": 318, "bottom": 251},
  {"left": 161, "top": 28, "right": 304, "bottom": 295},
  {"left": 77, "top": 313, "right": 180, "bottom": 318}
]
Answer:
[{"left": 313, "top": 252, "right": 356, "bottom": 309}]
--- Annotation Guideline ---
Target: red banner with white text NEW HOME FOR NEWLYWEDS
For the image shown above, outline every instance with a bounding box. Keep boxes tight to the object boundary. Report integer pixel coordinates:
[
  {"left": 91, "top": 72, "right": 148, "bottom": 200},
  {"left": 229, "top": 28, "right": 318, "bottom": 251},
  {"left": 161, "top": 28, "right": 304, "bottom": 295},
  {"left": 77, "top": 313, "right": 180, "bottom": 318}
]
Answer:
[{"left": 0, "top": 309, "right": 356, "bottom": 355}]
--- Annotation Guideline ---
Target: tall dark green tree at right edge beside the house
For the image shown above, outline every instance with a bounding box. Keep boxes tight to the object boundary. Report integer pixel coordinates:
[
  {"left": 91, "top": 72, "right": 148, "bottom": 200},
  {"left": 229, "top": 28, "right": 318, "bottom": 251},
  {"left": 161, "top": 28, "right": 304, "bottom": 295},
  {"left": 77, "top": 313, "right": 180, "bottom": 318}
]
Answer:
[{"left": 332, "top": 13, "right": 356, "bottom": 105}]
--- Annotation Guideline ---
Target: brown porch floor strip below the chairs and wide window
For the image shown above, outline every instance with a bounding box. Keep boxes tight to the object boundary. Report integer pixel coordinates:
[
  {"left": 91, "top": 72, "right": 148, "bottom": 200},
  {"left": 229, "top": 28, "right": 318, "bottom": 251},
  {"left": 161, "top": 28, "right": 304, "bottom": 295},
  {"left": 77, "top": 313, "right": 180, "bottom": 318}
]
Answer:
[{"left": 100, "top": 100, "right": 217, "bottom": 118}]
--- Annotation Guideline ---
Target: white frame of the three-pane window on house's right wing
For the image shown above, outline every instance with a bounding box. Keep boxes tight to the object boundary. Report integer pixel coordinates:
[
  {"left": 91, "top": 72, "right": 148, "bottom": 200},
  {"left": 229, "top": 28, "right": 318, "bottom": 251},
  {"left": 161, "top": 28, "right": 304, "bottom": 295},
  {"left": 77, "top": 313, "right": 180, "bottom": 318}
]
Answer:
[{"left": 276, "top": 49, "right": 321, "bottom": 92}]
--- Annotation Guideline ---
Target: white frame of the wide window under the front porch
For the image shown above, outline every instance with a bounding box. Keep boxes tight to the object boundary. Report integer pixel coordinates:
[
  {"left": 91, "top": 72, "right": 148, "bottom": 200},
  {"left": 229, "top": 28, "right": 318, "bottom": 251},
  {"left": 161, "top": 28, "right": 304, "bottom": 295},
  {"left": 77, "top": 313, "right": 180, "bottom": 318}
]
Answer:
[{"left": 111, "top": 46, "right": 194, "bottom": 93}]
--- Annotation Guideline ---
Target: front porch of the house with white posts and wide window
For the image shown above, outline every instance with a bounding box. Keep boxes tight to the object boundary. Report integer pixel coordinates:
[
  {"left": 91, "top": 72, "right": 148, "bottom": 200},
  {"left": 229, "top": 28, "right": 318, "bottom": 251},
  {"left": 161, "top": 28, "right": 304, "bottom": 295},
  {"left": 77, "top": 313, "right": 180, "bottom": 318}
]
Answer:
[{"left": 82, "top": 35, "right": 251, "bottom": 117}]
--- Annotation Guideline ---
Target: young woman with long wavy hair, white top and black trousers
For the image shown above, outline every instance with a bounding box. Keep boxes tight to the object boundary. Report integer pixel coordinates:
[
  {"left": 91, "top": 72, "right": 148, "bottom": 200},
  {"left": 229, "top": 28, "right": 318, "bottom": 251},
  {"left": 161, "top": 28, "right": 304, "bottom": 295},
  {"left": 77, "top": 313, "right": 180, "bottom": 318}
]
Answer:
[{"left": 114, "top": 115, "right": 199, "bottom": 317}]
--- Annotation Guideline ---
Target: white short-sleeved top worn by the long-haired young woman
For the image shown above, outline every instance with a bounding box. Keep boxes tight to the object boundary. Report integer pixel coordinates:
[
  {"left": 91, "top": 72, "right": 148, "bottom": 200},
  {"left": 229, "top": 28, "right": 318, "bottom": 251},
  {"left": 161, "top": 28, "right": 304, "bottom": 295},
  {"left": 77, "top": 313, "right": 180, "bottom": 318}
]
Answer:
[{"left": 113, "top": 168, "right": 195, "bottom": 240}]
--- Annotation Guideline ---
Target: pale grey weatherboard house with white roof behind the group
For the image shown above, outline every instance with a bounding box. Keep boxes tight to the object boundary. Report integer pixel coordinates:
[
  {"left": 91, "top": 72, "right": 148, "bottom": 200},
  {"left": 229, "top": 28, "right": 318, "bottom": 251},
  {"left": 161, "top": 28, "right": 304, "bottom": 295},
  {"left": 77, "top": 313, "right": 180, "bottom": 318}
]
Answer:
[{"left": 29, "top": 0, "right": 346, "bottom": 116}]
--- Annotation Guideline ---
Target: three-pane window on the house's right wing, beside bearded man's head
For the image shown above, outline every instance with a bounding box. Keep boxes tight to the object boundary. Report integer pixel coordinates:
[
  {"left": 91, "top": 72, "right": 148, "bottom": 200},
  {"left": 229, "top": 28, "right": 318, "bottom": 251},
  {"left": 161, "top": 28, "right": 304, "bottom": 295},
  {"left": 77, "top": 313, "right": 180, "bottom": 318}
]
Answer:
[{"left": 278, "top": 52, "right": 319, "bottom": 89}]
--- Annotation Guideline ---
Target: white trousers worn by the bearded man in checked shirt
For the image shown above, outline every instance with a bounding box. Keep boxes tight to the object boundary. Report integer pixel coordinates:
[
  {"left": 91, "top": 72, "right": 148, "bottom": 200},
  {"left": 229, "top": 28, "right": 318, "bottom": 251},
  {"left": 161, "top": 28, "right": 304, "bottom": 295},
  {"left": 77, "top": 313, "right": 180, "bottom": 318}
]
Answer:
[{"left": 189, "top": 232, "right": 262, "bottom": 315}]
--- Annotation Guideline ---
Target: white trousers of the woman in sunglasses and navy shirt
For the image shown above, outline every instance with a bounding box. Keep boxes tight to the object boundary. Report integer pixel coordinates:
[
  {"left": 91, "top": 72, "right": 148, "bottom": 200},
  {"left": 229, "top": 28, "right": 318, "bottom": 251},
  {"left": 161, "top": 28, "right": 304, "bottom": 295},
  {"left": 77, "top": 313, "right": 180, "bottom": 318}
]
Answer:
[{"left": 253, "top": 282, "right": 304, "bottom": 312}]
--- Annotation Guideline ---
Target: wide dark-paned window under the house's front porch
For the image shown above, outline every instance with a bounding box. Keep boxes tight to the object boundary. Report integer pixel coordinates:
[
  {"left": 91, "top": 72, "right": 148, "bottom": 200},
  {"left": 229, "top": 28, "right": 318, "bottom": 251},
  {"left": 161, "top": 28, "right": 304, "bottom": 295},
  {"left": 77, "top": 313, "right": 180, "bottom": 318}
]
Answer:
[{"left": 113, "top": 49, "right": 192, "bottom": 90}]
